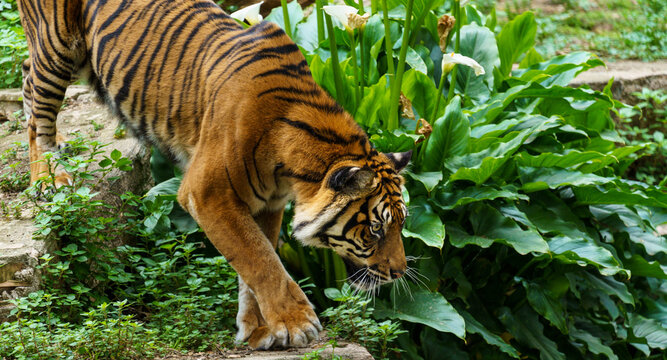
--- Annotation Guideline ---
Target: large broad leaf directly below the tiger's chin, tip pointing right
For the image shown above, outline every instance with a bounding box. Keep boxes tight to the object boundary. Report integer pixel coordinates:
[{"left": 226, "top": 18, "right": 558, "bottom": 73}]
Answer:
[{"left": 375, "top": 289, "right": 465, "bottom": 339}]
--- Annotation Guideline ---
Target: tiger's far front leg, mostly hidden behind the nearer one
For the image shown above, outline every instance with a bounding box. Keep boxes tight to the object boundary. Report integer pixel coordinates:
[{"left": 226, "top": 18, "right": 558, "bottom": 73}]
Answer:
[{"left": 236, "top": 210, "right": 283, "bottom": 347}]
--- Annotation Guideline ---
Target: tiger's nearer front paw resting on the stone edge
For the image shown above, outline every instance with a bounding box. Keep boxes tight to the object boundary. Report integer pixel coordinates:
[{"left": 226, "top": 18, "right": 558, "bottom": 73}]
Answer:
[{"left": 247, "top": 305, "right": 322, "bottom": 350}]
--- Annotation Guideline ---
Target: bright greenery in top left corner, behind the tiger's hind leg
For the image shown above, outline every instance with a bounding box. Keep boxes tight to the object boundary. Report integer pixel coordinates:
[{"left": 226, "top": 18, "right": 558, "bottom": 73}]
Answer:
[{"left": 0, "top": 0, "right": 28, "bottom": 88}]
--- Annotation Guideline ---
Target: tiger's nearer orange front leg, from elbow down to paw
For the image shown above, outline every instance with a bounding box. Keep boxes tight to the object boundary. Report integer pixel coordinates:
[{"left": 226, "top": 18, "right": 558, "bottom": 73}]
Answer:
[{"left": 178, "top": 167, "right": 322, "bottom": 349}]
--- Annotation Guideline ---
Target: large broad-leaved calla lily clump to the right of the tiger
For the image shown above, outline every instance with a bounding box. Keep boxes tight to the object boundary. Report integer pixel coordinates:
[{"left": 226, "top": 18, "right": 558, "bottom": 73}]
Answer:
[{"left": 267, "top": 0, "right": 667, "bottom": 359}]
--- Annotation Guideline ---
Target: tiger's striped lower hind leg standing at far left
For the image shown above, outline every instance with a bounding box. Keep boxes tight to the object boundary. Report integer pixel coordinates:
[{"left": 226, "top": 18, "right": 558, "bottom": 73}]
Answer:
[{"left": 22, "top": 54, "right": 74, "bottom": 188}]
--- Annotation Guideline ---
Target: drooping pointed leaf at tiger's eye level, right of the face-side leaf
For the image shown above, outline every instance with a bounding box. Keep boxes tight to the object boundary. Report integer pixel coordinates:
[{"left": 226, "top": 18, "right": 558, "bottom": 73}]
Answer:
[{"left": 470, "top": 203, "right": 549, "bottom": 255}]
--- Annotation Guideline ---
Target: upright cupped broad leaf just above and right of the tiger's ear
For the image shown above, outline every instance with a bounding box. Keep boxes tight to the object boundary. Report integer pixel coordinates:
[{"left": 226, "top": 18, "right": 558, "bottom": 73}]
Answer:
[{"left": 420, "top": 96, "right": 470, "bottom": 172}]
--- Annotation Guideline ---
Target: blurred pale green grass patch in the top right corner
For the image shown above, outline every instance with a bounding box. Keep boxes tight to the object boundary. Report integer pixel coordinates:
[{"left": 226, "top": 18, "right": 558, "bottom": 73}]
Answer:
[{"left": 498, "top": 0, "right": 667, "bottom": 60}]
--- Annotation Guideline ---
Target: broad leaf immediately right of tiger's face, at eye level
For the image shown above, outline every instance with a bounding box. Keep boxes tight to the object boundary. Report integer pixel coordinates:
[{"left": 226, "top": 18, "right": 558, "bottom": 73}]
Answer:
[{"left": 403, "top": 197, "right": 445, "bottom": 249}]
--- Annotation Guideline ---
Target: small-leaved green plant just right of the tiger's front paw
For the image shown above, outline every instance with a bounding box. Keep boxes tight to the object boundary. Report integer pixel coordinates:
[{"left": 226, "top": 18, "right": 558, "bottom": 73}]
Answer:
[{"left": 322, "top": 284, "right": 406, "bottom": 359}]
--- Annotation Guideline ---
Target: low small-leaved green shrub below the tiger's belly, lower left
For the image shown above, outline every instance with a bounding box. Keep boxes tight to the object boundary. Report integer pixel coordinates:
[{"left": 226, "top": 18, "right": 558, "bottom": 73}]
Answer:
[{"left": 0, "top": 138, "right": 236, "bottom": 359}]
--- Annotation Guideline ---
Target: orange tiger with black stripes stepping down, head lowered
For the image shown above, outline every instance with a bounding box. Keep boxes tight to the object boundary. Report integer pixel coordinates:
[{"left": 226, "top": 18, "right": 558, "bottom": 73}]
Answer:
[{"left": 18, "top": 0, "right": 412, "bottom": 349}]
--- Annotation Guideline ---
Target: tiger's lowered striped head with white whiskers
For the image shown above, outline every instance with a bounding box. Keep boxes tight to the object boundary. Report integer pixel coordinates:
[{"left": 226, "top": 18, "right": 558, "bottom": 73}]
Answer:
[{"left": 293, "top": 150, "right": 412, "bottom": 290}]
